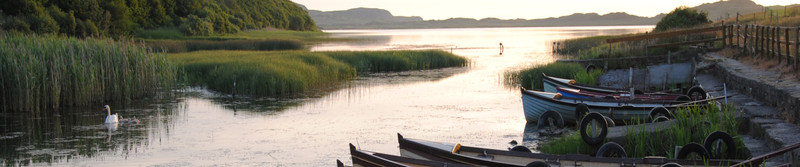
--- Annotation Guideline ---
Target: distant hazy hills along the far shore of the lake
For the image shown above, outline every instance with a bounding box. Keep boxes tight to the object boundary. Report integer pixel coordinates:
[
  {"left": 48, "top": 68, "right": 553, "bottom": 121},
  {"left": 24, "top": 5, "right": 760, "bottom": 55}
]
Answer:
[{"left": 308, "top": 0, "right": 780, "bottom": 29}]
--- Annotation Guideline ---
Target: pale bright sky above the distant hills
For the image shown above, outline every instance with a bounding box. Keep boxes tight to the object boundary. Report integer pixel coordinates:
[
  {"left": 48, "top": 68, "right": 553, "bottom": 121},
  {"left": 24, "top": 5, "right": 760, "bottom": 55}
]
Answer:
[{"left": 291, "top": 0, "right": 800, "bottom": 20}]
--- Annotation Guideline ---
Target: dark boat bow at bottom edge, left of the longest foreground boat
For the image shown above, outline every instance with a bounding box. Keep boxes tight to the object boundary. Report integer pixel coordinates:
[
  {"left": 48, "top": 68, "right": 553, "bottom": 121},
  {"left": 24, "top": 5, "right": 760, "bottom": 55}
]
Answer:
[{"left": 342, "top": 144, "right": 467, "bottom": 167}]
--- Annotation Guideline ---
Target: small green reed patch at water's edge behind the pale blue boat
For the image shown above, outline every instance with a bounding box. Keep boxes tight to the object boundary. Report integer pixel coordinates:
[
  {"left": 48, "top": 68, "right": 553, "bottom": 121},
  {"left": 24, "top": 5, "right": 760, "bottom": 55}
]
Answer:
[{"left": 504, "top": 62, "right": 603, "bottom": 90}]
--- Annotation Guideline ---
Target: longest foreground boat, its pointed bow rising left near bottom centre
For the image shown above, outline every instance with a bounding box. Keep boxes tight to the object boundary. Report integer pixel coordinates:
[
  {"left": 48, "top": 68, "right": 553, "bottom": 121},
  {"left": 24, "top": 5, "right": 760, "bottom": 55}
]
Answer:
[{"left": 397, "top": 134, "right": 737, "bottom": 167}]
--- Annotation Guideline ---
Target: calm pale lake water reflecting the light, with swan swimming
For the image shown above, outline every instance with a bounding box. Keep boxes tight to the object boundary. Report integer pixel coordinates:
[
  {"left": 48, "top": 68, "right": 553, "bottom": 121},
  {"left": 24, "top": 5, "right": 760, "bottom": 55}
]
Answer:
[{"left": 0, "top": 26, "right": 652, "bottom": 166}]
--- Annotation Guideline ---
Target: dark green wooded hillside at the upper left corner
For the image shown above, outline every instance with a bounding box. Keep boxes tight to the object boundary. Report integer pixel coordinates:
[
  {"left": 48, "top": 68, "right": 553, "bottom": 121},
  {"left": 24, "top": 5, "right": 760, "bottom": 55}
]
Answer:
[{"left": 0, "top": 0, "right": 318, "bottom": 37}]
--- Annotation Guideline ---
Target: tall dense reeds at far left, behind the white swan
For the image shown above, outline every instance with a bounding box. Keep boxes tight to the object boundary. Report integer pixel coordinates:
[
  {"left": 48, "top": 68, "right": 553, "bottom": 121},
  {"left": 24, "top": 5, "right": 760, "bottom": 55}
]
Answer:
[{"left": 0, "top": 33, "right": 176, "bottom": 112}]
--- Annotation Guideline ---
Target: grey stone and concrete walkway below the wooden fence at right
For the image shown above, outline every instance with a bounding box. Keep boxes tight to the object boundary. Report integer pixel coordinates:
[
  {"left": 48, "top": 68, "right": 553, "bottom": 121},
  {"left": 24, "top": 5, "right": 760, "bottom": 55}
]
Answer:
[{"left": 696, "top": 52, "right": 800, "bottom": 166}]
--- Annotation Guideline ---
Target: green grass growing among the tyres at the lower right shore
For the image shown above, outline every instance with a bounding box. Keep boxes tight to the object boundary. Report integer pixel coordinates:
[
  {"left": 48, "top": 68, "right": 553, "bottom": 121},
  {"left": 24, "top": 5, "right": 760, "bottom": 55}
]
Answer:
[{"left": 540, "top": 104, "right": 749, "bottom": 159}]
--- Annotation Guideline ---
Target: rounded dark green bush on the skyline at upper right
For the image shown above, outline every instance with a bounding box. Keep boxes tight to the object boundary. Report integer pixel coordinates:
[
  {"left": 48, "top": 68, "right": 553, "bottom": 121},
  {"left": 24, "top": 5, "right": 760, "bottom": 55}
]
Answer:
[{"left": 653, "top": 6, "right": 711, "bottom": 32}]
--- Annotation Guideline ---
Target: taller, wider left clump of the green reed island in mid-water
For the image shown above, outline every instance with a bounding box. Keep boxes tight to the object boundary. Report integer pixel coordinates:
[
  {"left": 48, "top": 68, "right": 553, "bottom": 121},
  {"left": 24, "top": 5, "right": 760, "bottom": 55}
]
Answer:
[{"left": 169, "top": 51, "right": 356, "bottom": 96}]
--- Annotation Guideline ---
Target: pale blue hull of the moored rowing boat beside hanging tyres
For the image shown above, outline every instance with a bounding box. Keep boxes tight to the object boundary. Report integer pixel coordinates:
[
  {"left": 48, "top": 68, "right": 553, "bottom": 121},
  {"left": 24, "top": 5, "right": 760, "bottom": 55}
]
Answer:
[{"left": 520, "top": 89, "right": 681, "bottom": 123}]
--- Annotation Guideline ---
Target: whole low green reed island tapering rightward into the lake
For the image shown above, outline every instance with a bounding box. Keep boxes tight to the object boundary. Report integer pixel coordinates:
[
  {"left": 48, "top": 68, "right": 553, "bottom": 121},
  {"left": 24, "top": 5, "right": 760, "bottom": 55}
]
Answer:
[{"left": 169, "top": 51, "right": 468, "bottom": 96}]
